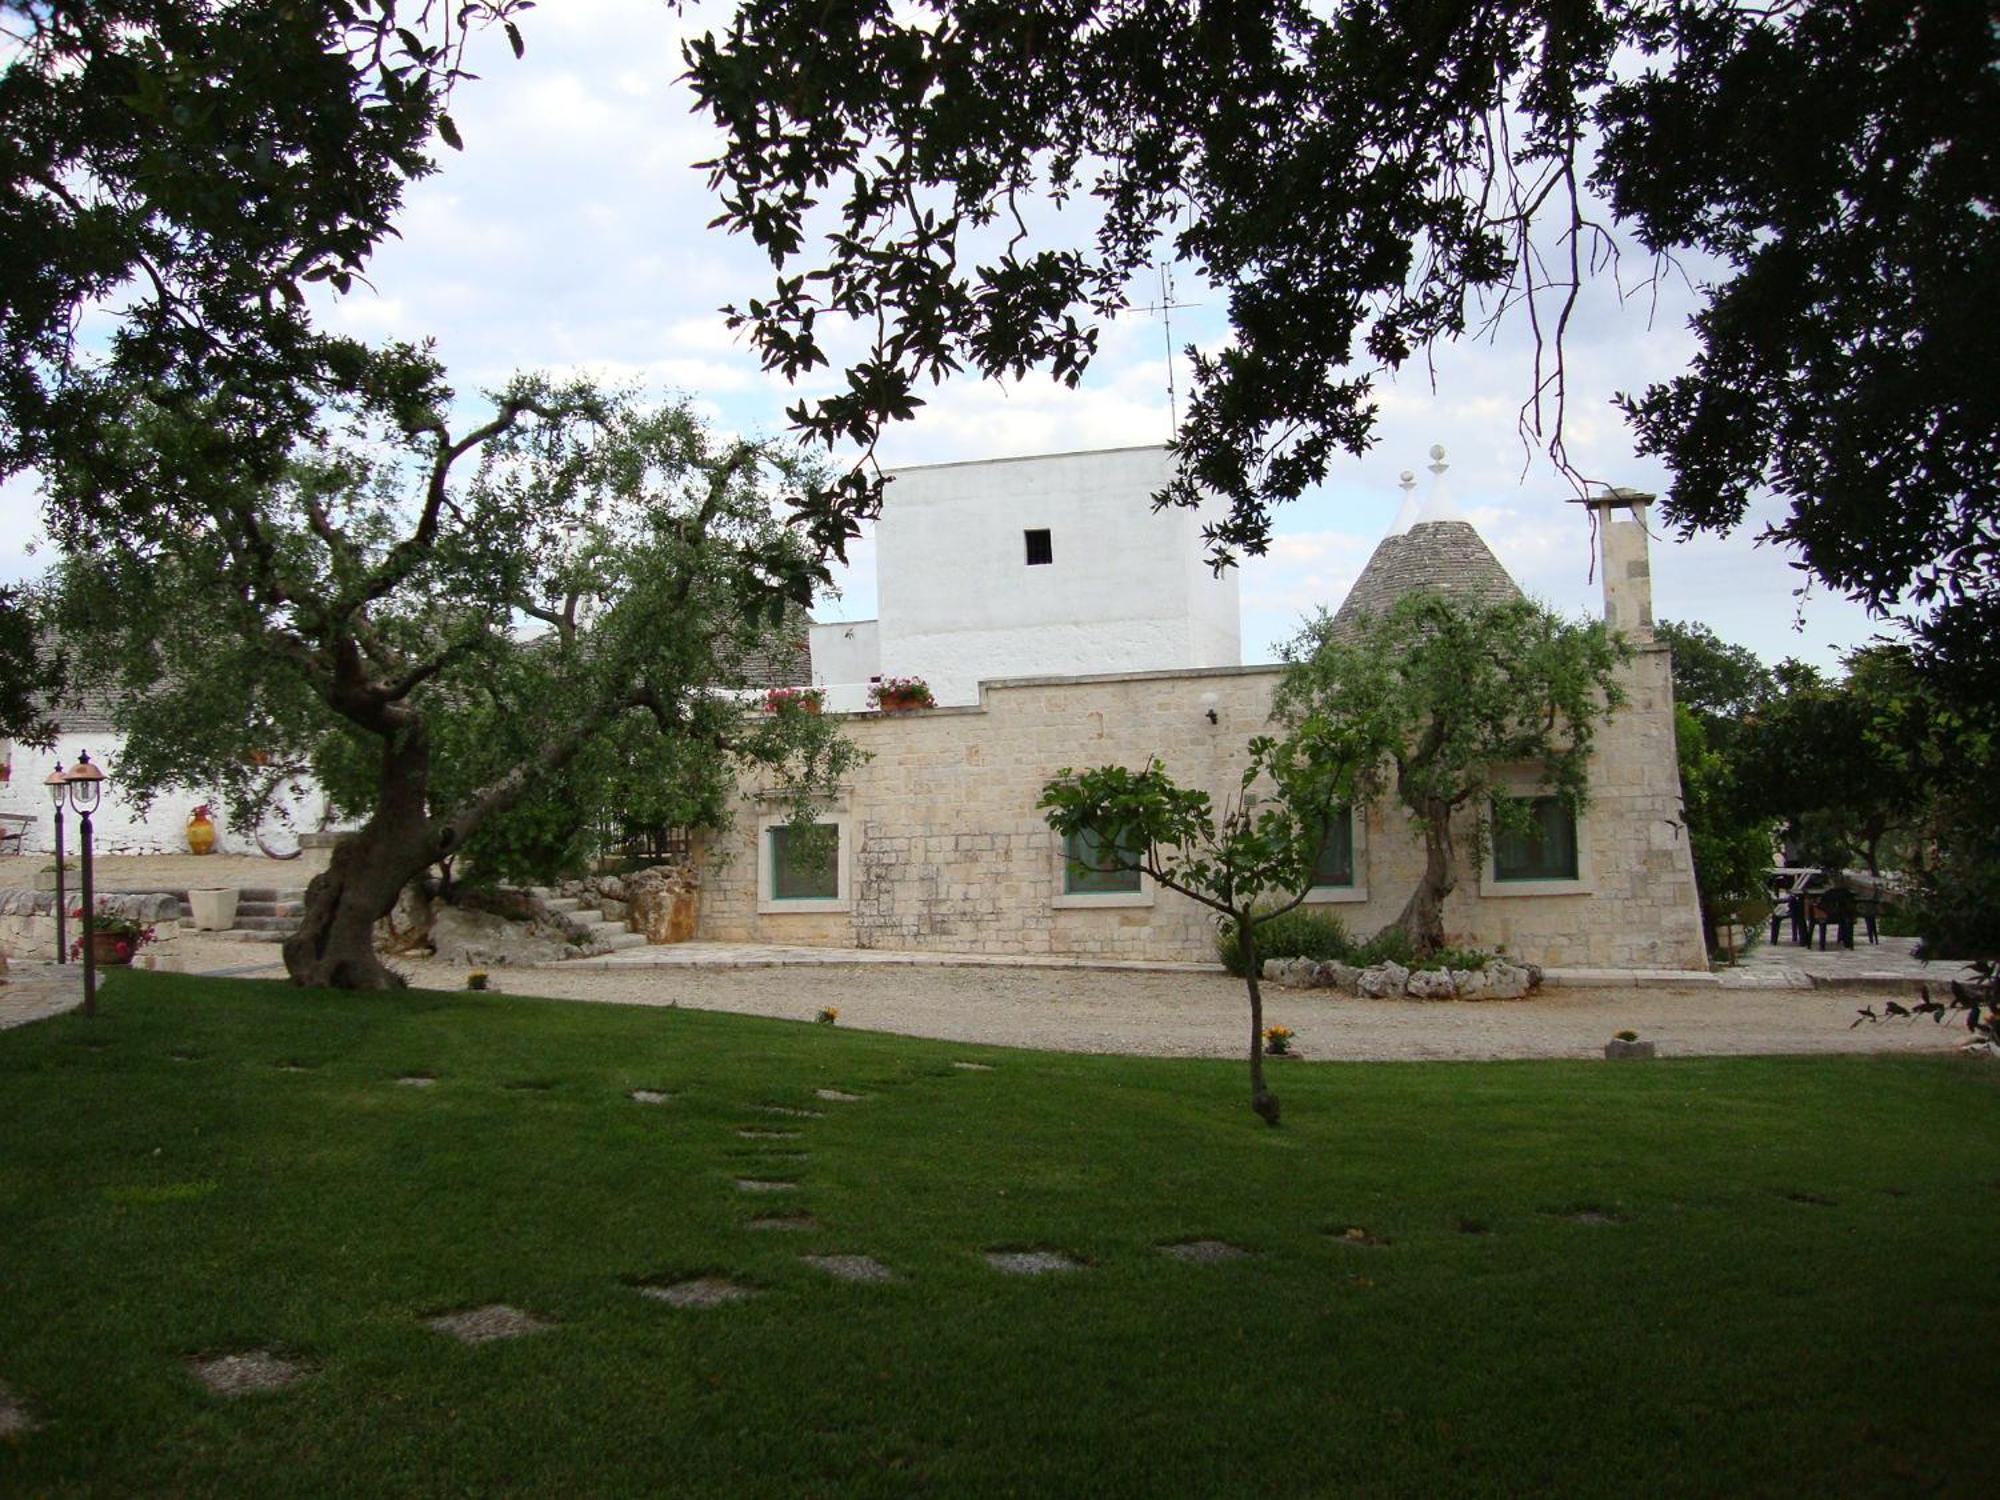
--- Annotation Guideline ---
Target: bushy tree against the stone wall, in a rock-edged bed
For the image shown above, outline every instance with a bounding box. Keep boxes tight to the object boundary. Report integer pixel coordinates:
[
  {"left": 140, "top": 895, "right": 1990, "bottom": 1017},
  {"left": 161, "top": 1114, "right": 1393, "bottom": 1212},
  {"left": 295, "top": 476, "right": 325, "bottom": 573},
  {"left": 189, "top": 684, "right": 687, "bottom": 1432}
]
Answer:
[{"left": 1272, "top": 592, "right": 1630, "bottom": 956}]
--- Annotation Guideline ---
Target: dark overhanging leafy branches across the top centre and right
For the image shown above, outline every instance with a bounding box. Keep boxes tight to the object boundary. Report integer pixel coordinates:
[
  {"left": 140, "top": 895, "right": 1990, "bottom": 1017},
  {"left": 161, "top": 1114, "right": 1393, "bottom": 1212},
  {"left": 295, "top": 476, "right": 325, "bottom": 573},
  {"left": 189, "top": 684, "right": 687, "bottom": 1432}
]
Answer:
[{"left": 688, "top": 0, "right": 2000, "bottom": 680}]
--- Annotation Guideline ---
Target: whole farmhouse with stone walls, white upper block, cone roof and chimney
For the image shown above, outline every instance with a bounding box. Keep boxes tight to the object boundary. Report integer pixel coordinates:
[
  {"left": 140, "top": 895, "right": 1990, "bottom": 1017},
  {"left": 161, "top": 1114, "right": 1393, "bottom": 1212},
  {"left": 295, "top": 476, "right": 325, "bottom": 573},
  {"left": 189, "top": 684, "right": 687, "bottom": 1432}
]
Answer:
[{"left": 698, "top": 448, "right": 1706, "bottom": 970}]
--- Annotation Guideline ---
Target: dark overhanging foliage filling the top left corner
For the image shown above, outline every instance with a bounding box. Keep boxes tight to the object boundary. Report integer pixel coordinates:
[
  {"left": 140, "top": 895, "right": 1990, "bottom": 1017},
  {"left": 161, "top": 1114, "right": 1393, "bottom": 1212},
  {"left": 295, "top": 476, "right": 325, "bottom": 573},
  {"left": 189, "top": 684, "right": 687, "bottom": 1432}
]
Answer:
[{"left": 0, "top": 0, "right": 526, "bottom": 512}]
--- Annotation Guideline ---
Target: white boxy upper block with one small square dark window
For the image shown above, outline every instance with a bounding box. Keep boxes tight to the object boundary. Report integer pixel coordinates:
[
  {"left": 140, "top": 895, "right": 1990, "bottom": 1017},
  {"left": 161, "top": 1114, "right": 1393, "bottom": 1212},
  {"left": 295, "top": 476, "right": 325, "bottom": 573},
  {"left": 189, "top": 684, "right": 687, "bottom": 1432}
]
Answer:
[{"left": 812, "top": 446, "right": 1242, "bottom": 712}]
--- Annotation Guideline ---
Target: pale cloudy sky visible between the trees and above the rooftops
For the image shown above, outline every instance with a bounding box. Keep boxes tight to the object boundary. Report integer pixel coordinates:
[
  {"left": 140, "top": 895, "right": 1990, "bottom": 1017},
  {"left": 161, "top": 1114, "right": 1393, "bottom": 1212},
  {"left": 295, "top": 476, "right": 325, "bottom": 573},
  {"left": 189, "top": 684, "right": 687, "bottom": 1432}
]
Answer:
[{"left": 0, "top": 0, "right": 1874, "bottom": 664}]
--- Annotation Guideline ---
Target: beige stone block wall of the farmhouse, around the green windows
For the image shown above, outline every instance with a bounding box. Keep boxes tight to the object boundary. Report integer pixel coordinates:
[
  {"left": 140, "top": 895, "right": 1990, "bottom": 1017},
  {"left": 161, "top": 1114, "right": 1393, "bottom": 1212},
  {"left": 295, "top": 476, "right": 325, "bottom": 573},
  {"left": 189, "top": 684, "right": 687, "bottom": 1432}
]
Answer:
[{"left": 700, "top": 648, "right": 1706, "bottom": 968}]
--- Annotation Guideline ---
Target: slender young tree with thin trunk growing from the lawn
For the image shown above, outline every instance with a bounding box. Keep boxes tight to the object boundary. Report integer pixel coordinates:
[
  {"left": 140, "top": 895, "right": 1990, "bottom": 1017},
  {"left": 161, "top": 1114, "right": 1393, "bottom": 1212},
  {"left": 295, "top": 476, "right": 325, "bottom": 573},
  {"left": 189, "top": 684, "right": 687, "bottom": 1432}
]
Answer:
[{"left": 1038, "top": 718, "right": 1370, "bottom": 1124}]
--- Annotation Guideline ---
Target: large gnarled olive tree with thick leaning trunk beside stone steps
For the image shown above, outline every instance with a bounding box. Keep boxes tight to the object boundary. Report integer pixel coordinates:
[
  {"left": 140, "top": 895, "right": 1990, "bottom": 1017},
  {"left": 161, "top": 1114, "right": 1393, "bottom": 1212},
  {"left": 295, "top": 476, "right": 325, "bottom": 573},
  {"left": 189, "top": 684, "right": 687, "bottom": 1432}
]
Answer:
[{"left": 50, "top": 380, "right": 852, "bottom": 988}]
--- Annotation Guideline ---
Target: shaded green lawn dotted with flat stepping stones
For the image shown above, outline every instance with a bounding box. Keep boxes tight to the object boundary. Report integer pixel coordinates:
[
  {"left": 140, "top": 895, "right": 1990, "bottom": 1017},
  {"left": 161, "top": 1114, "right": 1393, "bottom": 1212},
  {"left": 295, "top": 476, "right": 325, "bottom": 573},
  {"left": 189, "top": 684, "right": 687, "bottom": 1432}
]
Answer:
[{"left": 0, "top": 974, "right": 2000, "bottom": 1496}]
